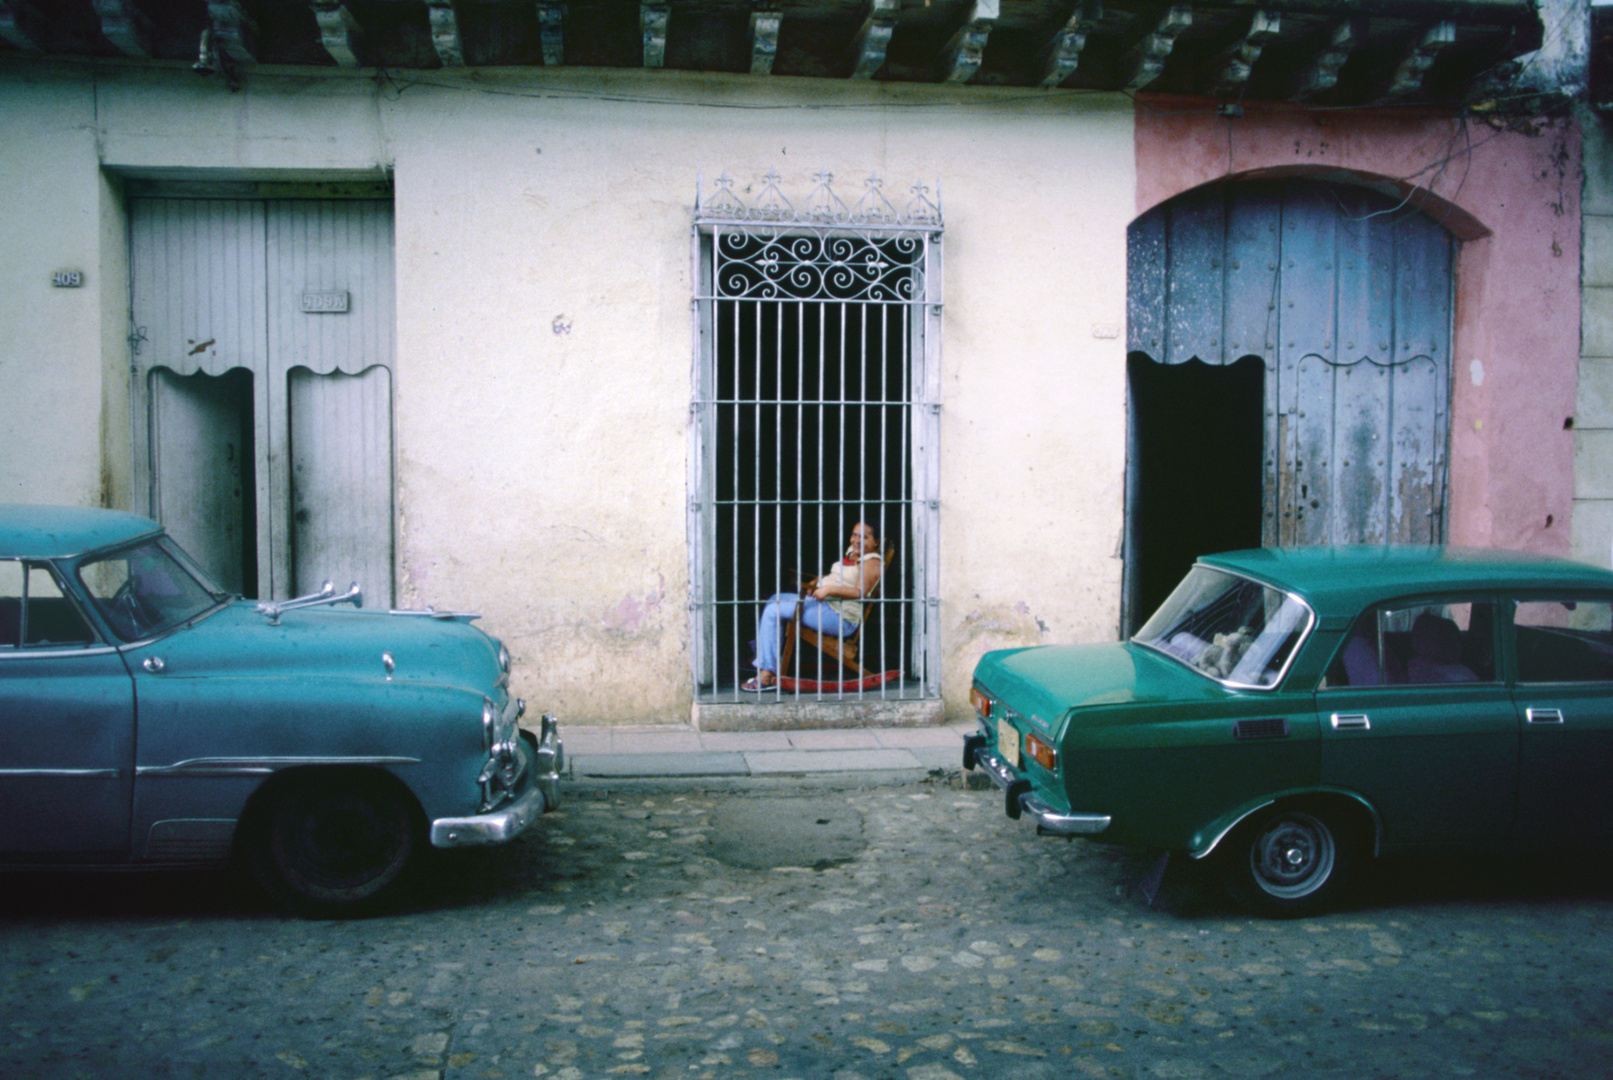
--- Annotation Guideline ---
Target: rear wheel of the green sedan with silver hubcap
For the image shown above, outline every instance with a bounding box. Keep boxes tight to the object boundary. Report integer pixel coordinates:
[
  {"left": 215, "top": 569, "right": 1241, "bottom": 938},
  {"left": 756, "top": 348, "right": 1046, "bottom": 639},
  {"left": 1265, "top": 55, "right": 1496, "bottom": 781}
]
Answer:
[{"left": 1221, "top": 806, "right": 1357, "bottom": 919}]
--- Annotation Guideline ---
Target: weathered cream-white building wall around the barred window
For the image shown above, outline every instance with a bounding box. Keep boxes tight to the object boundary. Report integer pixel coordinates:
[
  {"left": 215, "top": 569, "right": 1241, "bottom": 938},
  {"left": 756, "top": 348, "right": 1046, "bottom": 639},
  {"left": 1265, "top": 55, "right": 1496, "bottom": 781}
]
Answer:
[{"left": 0, "top": 57, "right": 1136, "bottom": 724}]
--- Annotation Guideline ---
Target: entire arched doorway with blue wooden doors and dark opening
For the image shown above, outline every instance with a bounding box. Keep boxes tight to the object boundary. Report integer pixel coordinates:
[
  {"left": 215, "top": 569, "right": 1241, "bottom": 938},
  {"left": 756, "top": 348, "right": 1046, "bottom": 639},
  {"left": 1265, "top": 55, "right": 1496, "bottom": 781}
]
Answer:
[{"left": 1123, "top": 179, "right": 1455, "bottom": 632}]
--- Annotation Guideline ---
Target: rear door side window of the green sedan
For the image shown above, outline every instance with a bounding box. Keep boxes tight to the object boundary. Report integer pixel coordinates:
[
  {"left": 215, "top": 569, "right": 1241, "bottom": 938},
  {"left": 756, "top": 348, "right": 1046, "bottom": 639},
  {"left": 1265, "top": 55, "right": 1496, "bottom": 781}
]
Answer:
[{"left": 1324, "top": 600, "right": 1495, "bottom": 688}]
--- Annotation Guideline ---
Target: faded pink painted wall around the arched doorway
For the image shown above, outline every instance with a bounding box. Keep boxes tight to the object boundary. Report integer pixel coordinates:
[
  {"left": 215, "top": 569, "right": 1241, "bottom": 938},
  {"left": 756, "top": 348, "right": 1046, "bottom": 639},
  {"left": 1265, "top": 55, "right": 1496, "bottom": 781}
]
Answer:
[{"left": 1136, "top": 97, "right": 1581, "bottom": 555}]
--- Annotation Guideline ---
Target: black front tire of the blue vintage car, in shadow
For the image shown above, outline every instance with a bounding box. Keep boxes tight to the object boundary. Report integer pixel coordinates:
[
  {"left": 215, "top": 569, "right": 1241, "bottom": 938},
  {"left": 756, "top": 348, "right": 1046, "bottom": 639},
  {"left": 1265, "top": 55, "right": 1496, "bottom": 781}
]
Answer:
[{"left": 250, "top": 772, "right": 419, "bottom": 917}]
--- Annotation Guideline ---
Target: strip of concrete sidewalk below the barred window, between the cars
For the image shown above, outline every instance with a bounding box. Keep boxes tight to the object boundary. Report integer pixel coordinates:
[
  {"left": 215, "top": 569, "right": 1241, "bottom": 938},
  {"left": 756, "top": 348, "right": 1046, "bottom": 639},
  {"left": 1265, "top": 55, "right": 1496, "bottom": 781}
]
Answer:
[{"left": 560, "top": 721, "right": 974, "bottom": 788}]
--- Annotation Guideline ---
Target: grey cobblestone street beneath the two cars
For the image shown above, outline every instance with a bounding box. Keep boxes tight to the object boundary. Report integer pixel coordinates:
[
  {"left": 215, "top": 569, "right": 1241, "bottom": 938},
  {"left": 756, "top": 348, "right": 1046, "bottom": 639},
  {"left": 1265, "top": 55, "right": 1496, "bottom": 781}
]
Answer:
[{"left": 0, "top": 779, "right": 1613, "bottom": 1080}]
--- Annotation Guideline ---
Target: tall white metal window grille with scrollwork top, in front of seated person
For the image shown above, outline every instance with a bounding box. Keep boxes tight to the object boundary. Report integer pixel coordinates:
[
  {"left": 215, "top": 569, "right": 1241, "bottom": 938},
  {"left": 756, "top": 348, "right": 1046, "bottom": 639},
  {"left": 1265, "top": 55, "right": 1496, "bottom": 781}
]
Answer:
[{"left": 689, "top": 172, "right": 940, "bottom": 701}]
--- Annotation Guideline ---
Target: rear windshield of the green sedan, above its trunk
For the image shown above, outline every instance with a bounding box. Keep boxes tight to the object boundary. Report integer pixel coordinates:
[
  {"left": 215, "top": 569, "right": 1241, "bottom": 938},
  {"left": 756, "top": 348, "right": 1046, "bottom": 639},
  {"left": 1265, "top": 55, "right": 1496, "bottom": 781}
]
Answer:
[{"left": 1132, "top": 566, "right": 1311, "bottom": 688}]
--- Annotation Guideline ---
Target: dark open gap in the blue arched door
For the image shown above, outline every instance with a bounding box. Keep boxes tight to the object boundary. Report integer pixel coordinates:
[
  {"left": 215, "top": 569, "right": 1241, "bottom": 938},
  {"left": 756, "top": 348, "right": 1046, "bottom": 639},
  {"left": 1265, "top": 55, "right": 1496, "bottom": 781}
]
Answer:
[{"left": 1121, "top": 353, "right": 1266, "bottom": 635}]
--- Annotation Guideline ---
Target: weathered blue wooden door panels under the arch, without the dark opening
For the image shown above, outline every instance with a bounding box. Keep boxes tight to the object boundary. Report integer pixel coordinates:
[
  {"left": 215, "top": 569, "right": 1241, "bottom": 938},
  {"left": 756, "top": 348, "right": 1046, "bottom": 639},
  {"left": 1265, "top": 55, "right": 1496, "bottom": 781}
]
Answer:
[{"left": 1127, "top": 181, "right": 1455, "bottom": 553}]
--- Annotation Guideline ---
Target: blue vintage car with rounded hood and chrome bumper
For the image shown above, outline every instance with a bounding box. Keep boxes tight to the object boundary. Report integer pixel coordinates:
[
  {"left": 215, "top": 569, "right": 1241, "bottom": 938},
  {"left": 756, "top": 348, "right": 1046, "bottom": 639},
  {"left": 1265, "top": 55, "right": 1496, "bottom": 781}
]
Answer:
[{"left": 0, "top": 505, "right": 563, "bottom": 914}]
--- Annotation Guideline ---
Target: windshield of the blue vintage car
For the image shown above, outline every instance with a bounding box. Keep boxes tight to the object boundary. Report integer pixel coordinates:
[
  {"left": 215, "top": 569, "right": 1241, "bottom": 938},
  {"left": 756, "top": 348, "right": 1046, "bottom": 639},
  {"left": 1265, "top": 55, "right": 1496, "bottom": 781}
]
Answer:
[{"left": 79, "top": 537, "right": 226, "bottom": 642}]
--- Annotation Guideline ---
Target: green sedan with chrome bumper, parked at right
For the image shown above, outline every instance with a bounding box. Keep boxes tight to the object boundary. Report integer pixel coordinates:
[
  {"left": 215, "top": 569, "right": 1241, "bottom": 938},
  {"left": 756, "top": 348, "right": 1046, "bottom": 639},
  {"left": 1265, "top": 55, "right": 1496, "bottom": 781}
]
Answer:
[{"left": 963, "top": 546, "right": 1613, "bottom": 917}]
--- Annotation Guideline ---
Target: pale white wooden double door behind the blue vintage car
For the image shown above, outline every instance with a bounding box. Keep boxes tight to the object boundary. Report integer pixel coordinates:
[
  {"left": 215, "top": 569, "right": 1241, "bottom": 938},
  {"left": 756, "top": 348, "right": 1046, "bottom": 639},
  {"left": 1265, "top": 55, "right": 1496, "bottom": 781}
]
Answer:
[{"left": 129, "top": 197, "right": 395, "bottom": 604}]
